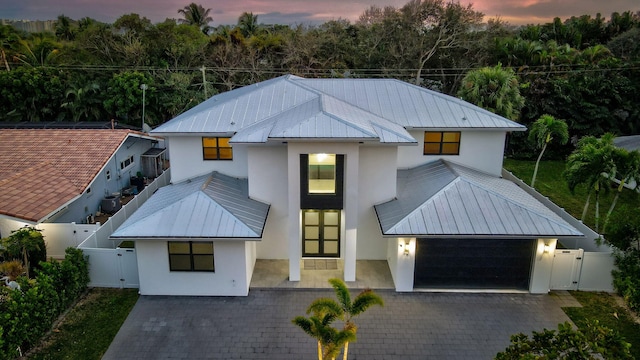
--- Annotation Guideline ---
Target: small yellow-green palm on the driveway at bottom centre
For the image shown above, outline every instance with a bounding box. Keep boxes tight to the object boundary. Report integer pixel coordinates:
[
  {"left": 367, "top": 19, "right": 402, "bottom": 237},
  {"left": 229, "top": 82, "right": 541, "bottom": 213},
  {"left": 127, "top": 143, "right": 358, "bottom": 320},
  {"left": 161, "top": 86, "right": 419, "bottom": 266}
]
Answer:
[{"left": 292, "top": 278, "right": 384, "bottom": 360}]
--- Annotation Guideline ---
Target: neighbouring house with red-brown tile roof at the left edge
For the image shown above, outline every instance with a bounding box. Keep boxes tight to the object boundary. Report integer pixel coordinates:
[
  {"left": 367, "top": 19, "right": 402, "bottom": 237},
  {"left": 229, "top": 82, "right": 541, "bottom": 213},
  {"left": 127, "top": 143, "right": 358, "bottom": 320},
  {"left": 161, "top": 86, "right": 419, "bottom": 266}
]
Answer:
[{"left": 0, "top": 129, "right": 164, "bottom": 250}]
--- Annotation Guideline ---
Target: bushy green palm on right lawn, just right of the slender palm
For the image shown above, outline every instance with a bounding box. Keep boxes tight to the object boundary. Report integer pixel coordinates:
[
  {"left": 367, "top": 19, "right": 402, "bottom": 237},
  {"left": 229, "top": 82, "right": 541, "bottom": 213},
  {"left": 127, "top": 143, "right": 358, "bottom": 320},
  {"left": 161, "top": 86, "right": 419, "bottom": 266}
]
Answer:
[{"left": 563, "top": 133, "right": 615, "bottom": 231}]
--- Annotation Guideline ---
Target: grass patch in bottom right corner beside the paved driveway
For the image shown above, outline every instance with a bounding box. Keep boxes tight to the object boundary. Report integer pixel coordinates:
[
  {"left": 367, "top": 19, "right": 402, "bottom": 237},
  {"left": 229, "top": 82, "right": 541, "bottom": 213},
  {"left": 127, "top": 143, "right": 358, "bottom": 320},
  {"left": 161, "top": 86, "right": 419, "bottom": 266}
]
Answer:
[{"left": 563, "top": 291, "right": 640, "bottom": 359}]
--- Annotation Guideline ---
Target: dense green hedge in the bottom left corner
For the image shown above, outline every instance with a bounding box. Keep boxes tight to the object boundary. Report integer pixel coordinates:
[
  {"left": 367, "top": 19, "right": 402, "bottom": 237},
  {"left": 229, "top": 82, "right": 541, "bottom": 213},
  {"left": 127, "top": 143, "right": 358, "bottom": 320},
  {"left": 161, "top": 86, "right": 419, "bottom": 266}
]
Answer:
[{"left": 0, "top": 248, "right": 89, "bottom": 359}]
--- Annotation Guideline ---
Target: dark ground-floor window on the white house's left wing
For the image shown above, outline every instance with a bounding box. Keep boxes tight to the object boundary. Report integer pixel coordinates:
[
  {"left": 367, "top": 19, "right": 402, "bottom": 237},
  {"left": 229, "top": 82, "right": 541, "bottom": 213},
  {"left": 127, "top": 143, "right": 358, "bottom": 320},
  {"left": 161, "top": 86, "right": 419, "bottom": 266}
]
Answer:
[{"left": 169, "top": 241, "right": 215, "bottom": 271}]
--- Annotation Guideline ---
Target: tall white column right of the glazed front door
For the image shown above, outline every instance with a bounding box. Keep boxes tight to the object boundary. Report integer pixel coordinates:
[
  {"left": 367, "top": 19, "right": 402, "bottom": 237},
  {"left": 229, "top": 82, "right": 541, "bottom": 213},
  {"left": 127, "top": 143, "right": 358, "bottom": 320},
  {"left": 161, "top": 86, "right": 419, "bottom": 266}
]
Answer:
[{"left": 344, "top": 148, "right": 360, "bottom": 281}]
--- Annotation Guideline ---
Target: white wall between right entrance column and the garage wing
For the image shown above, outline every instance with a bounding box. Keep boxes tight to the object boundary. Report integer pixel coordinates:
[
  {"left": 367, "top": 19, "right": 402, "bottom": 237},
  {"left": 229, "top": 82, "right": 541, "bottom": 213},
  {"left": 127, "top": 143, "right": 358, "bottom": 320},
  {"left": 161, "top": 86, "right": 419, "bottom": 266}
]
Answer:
[{"left": 357, "top": 146, "right": 398, "bottom": 260}]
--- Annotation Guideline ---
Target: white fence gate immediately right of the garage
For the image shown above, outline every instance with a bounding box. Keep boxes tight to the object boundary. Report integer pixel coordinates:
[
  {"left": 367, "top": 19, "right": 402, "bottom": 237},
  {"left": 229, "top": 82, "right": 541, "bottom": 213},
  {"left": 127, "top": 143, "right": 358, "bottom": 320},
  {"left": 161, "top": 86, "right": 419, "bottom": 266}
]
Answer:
[{"left": 549, "top": 249, "right": 584, "bottom": 290}]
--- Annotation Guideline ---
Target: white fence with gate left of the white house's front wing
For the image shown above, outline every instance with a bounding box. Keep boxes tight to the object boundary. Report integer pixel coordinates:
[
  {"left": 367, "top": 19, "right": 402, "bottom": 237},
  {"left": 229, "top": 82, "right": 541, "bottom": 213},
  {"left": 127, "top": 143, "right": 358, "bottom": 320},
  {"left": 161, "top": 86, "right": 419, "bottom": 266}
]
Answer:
[{"left": 78, "top": 170, "right": 171, "bottom": 288}]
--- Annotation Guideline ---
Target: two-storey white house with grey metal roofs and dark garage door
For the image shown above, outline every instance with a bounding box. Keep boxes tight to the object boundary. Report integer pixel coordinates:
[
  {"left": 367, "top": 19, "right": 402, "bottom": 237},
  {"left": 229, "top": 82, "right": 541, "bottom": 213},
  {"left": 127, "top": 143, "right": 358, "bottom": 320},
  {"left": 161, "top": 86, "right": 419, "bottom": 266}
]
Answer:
[{"left": 111, "top": 76, "right": 585, "bottom": 295}]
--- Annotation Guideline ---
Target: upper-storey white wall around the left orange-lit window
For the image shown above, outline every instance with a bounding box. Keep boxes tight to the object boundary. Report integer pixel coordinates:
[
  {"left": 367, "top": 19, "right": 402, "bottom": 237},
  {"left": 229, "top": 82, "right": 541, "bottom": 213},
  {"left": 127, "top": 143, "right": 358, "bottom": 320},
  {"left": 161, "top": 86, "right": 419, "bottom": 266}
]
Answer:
[{"left": 169, "top": 136, "right": 247, "bottom": 183}]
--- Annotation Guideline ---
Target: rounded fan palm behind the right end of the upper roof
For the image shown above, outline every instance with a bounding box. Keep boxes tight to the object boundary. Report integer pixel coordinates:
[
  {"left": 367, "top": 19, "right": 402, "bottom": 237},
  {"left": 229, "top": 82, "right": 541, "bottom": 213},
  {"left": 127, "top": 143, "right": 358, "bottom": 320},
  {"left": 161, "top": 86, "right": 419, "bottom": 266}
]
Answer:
[{"left": 458, "top": 64, "right": 524, "bottom": 121}]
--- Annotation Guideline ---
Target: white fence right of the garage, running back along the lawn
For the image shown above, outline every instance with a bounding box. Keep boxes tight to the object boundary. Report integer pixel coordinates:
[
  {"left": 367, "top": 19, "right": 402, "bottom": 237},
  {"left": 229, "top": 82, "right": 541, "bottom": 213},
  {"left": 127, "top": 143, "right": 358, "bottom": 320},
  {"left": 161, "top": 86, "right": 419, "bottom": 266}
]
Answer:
[{"left": 502, "top": 170, "right": 615, "bottom": 292}]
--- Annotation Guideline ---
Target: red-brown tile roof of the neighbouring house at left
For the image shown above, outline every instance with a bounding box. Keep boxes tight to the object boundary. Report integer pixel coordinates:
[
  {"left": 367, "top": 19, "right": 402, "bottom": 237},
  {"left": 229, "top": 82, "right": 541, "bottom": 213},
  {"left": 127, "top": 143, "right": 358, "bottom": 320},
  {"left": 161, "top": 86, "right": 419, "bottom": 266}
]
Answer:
[{"left": 0, "top": 129, "right": 138, "bottom": 222}]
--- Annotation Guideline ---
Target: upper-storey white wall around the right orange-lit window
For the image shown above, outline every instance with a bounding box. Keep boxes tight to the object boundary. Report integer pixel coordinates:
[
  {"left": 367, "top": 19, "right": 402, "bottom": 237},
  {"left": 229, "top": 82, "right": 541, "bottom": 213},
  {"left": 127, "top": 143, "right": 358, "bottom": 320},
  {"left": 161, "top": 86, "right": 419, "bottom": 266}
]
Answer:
[{"left": 398, "top": 130, "right": 505, "bottom": 176}]
